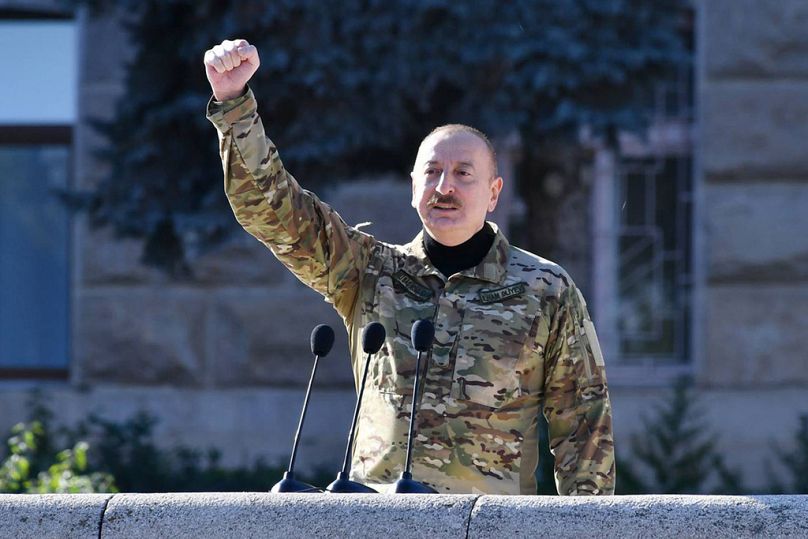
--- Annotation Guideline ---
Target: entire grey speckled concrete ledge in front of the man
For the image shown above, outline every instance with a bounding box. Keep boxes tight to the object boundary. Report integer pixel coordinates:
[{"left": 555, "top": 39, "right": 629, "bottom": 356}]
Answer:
[{"left": 0, "top": 493, "right": 808, "bottom": 539}]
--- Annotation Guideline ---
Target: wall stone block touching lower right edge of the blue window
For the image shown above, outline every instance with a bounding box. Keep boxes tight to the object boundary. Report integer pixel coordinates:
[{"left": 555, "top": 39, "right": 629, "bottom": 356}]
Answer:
[{"left": 74, "top": 287, "right": 206, "bottom": 386}]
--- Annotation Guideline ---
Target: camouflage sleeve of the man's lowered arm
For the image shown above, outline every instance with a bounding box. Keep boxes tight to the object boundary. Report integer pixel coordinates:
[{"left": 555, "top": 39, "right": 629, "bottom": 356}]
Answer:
[{"left": 544, "top": 283, "right": 615, "bottom": 495}]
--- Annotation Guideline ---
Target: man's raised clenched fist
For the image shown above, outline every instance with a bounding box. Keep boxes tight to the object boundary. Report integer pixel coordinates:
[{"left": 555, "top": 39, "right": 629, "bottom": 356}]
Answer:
[{"left": 205, "top": 39, "right": 261, "bottom": 101}]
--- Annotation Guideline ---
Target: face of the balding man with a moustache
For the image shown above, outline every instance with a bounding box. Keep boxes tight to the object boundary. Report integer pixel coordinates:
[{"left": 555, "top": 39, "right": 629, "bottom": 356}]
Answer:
[{"left": 410, "top": 131, "right": 502, "bottom": 247}]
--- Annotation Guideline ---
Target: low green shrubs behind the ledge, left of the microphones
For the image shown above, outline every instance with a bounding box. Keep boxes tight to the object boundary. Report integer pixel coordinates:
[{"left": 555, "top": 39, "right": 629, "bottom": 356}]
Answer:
[{"left": 0, "top": 400, "right": 336, "bottom": 493}]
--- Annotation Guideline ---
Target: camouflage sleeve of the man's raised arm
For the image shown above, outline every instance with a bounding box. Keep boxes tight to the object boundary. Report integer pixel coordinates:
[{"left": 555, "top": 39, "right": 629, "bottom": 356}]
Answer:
[{"left": 207, "top": 89, "right": 374, "bottom": 318}]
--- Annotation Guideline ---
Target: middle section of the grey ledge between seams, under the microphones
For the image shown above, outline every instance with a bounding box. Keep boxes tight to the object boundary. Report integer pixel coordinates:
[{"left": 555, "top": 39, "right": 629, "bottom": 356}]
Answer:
[{"left": 102, "top": 493, "right": 480, "bottom": 539}]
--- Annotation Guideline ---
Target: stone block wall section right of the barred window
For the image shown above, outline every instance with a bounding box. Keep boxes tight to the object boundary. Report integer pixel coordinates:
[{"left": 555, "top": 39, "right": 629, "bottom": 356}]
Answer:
[{"left": 698, "top": 0, "right": 808, "bottom": 388}]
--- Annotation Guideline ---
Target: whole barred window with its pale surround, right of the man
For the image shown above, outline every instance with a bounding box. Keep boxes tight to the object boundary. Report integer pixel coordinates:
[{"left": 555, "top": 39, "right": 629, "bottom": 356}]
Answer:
[{"left": 592, "top": 64, "right": 694, "bottom": 385}]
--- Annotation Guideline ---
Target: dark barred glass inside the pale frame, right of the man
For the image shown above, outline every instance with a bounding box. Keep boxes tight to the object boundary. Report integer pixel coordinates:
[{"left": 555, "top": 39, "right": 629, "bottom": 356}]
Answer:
[{"left": 617, "top": 156, "right": 692, "bottom": 364}]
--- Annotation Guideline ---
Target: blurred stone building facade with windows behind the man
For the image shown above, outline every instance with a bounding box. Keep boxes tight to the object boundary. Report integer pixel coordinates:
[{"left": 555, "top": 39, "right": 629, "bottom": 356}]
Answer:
[{"left": 0, "top": 0, "right": 808, "bottom": 489}]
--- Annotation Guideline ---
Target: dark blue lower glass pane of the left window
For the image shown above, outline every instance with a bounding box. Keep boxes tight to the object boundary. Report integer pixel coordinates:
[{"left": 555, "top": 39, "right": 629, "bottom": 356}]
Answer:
[{"left": 0, "top": 144, "right": 70, "bottom": 369}]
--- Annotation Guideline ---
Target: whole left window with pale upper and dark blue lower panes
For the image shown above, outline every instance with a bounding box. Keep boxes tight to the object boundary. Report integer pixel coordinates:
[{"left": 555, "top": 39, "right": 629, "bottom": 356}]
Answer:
[{"left": 0, "top": 20, "right": 77, "bottom": 378}]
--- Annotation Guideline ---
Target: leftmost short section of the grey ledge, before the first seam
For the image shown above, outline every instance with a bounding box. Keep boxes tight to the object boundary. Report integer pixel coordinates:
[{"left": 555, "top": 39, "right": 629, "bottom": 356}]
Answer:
[{"left": 0, "top": 494, "right": 112, "bottom": 539}]
